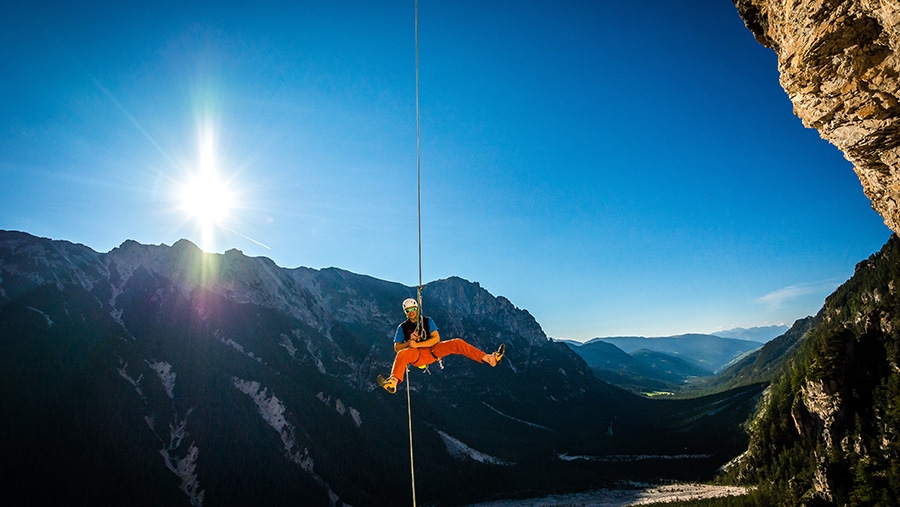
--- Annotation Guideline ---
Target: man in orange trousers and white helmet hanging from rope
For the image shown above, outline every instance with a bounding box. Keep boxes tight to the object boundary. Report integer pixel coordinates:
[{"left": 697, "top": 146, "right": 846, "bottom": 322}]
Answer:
[{"left": 378, "top": 298, "right": 506, "bottom": 394}]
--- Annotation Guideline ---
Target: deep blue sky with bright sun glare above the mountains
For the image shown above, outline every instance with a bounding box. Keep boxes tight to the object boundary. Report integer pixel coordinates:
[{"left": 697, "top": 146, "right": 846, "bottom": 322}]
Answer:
[{"left": 0, "top": 0, "right": 890, "bottom": 340}]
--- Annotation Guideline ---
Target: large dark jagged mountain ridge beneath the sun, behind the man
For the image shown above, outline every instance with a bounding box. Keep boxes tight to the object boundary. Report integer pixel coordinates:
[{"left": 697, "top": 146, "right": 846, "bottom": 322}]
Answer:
[{"left": 0, "top": 231, "right": 758, "bottom": 506}]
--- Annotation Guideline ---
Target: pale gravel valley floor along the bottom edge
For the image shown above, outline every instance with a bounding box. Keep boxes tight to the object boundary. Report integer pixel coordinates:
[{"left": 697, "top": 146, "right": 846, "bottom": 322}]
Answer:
[{"left": 460, "top": 484, "right": 747, "bottom": 507}]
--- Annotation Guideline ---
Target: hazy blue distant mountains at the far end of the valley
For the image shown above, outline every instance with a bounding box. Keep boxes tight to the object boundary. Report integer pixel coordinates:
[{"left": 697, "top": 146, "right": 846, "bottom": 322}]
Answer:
[{"left": 588, "top": 334, "right": 760, "bottom": 372}]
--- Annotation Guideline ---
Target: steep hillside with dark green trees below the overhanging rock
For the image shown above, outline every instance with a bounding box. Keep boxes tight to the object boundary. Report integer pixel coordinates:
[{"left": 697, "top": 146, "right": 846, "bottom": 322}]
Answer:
[{"left": 732, "top": 235, "right": 900, "bottom": 507}]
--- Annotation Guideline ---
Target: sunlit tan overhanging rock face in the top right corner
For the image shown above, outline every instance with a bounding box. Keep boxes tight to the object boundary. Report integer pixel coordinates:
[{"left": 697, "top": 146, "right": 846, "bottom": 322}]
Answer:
[{"left": 734, "top": 0, "right": 900, "bottom": 233}]
